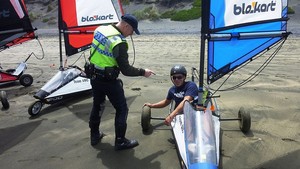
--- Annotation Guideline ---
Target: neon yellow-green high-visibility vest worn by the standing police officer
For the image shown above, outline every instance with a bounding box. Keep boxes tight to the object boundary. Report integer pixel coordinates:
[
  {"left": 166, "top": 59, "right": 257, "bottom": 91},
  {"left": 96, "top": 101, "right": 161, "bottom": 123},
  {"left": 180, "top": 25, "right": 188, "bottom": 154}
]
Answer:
[{"left": 90, "top": 25, "right": 128, "bottom": 69}]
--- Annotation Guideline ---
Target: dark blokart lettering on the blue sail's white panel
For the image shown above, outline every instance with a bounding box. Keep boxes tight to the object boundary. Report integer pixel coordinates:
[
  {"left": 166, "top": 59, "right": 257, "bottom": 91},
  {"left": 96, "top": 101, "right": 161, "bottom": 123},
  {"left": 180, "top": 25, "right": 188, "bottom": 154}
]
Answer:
[{"left": 233, "top": 1, "right": 276, "bottom": 15}]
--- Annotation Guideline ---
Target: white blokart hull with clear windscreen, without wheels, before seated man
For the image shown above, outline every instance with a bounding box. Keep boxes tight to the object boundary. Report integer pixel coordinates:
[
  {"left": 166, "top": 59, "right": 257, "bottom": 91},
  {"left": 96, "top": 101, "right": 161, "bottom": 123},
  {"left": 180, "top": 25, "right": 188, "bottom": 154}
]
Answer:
[{"left": 171, "top": 102, "right": 220, "bottom": 169}]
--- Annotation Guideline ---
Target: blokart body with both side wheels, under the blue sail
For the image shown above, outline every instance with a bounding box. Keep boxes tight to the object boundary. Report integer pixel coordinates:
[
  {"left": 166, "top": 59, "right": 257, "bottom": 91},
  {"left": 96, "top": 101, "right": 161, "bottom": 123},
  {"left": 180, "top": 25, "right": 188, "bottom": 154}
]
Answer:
[{"left": 141, "top": 93, "right": 251, "bottom": 169}]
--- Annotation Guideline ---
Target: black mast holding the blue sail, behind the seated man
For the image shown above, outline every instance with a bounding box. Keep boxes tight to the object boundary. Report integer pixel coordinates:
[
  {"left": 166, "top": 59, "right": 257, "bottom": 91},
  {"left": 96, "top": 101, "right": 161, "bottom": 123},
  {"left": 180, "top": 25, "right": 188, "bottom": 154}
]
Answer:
[{"left": 198, "top": 0, "right": 210, "bottom": 106}]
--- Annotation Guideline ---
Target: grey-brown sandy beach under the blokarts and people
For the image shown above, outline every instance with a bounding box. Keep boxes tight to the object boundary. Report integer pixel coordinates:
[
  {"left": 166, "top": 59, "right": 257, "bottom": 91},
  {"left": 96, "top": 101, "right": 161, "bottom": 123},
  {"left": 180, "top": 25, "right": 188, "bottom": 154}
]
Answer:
[{"left": 0, "top": 1, "right": 300, "bottom": 169}]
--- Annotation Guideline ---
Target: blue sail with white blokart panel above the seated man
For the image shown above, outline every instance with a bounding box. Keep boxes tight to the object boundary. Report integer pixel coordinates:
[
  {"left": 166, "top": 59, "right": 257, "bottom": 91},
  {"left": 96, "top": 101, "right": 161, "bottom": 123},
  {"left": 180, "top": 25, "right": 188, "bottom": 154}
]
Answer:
[{"left": 207, "top": 0, "right": 288, "bottom": 84}]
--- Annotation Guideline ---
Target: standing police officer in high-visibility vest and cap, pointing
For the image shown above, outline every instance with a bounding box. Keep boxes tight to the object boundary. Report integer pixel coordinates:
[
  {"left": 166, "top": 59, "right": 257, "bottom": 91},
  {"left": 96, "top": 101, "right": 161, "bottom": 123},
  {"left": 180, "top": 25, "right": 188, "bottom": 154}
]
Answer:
[{"left": 89, "top": 14, "right": 154, "bottom": 150}]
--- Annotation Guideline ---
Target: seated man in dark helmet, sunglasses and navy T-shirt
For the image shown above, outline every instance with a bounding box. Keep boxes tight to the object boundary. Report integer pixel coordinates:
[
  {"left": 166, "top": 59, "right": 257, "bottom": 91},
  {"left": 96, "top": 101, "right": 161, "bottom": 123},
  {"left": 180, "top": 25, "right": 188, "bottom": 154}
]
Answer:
[{"left": 144, "top": 65, "right": 198, "bottom": 125}]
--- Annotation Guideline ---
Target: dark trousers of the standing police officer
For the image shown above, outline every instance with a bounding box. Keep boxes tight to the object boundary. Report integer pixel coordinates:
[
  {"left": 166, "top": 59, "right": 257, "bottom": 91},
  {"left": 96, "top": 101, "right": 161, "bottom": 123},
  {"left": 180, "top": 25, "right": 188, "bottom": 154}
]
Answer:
[{"left": 89, "top": 78, "right": 128, "bottom": 138}]
